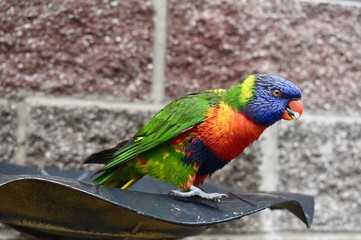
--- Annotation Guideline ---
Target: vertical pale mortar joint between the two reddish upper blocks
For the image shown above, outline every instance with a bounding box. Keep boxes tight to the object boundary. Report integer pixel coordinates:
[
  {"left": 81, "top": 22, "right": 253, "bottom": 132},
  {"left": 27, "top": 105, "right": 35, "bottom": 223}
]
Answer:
[{"left": 151, "top": 0, "right": 167, "bottom": 103}]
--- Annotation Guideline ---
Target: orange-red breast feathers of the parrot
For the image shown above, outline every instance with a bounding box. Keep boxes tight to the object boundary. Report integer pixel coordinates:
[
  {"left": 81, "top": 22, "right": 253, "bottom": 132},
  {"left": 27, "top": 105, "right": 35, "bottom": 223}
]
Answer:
[{"left": 196, "top": 103, "right": 266, "bottom": 160}]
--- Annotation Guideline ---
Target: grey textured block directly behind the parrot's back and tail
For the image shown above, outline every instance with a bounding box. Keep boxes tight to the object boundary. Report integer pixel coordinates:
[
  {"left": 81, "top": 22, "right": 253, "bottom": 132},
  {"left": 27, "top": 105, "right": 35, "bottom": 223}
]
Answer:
[{"left": 27, "top": 106, "right": 150, "bottom": 169}]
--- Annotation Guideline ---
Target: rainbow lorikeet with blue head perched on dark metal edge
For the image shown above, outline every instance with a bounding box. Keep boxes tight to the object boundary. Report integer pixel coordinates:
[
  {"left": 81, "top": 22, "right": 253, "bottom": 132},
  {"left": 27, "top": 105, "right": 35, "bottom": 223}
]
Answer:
[{"left": 85, "top": 74, "right": 303, "bottom": 200}]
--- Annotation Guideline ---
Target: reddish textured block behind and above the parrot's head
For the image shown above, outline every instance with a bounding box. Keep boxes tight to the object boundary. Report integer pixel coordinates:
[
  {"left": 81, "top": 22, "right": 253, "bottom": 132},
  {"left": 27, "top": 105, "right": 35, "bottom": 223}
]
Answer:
[{"left": 167, "top": 0, "right": 361, "bottom": 113}]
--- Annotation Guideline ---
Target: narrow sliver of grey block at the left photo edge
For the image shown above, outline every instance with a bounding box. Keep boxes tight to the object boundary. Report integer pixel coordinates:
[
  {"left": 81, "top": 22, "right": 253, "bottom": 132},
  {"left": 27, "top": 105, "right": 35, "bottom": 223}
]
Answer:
[{"left": 0, "top": 101, "right": 18, "bottom": 162}]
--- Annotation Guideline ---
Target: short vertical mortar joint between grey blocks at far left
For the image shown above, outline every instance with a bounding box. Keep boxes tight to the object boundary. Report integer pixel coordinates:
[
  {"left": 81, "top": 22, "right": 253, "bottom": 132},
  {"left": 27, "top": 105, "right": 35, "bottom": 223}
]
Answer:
[{"left": 13, "top": 100, "right": 28, "bottom": 165}]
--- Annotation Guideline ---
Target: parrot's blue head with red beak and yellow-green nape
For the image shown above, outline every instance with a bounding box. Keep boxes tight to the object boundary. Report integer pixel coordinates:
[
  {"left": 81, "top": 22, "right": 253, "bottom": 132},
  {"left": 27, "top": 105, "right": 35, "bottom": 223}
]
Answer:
[{"left": 241, "top": 74, "right": 303, "bottom": 126}]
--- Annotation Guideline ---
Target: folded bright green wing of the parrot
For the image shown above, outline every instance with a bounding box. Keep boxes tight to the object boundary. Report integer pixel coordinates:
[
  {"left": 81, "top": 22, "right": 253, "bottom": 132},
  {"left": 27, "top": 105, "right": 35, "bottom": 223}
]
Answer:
[{"left": 101, "top": 91, "right": 222, "bottom": 171}]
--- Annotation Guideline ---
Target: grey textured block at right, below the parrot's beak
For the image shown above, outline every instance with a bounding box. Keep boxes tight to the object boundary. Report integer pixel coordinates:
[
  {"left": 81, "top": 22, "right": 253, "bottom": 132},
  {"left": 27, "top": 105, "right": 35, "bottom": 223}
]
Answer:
[{"left": 275, "top": 121, "right": 361, "bottom": 231}]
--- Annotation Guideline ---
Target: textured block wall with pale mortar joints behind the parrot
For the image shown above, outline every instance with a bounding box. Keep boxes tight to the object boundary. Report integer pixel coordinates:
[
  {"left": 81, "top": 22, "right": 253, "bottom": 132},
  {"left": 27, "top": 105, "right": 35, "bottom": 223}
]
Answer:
[{"left": 0, "top": 0, "right": 361, "bottom": 239}]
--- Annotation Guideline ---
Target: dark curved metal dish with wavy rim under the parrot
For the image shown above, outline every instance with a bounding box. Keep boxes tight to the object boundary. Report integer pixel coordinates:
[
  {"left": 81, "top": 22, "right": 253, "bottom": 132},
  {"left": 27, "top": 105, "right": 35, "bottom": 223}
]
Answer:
[{"left": 0, "top": 163, "right": 314, "bottom": 240}]
